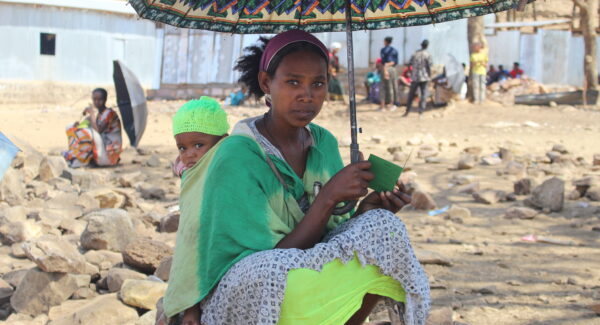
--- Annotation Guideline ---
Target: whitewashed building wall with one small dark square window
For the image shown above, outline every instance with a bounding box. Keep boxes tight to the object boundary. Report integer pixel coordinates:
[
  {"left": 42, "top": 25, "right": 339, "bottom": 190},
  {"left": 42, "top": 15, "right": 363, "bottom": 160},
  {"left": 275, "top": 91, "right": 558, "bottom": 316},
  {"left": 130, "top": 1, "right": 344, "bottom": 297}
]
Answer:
[{"left": 0, "top": 3, "right": 160, "bottom": 86}]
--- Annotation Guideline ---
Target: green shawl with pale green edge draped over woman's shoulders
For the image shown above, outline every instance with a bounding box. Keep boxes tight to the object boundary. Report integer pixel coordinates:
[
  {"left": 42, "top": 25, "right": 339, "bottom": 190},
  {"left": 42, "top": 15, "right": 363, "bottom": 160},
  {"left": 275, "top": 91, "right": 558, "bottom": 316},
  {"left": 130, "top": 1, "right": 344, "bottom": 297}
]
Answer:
[{"left": 164, "top": 120, "right": 349, "bottom": 317}]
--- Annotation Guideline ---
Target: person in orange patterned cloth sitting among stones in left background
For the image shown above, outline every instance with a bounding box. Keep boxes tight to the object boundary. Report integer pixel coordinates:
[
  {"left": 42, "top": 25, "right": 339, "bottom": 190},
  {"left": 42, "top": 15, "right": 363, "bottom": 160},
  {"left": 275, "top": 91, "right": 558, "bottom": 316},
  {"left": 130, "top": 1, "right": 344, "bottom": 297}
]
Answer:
[{"left": 63, "top": 88, "right": 122, "bottom": 168}]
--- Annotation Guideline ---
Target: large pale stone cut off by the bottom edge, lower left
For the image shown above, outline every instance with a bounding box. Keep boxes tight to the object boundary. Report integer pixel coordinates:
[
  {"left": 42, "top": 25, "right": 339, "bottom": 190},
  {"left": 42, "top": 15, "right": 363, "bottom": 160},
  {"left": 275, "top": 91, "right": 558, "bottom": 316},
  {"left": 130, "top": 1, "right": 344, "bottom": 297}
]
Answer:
[{"left": 48, "top": 294, "right": 139, "bottom": 325}]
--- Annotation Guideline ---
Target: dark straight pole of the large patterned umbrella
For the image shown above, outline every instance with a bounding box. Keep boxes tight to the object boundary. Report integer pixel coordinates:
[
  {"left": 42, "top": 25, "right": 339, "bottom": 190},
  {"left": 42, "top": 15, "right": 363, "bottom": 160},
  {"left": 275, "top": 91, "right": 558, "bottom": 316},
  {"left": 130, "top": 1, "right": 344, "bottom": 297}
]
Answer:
[{"left": 346, "top": 0, "right": 360, "bottom": 163}]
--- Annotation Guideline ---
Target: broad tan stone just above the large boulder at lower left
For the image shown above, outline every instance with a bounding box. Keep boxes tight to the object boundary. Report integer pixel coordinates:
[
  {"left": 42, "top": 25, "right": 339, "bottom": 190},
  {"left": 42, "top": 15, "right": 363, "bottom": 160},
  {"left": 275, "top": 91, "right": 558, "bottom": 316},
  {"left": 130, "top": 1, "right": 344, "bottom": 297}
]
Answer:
[{"left": 23, "top": 235, "right": 86, "bottom": 274}]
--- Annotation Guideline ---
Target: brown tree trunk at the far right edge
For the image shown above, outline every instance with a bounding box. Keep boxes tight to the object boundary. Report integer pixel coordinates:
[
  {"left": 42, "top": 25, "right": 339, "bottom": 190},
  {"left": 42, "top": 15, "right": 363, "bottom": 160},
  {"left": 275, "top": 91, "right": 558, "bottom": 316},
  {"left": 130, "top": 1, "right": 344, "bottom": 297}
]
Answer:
[{"left": 573, "top": 0, "right": 598, "bottom": 93}]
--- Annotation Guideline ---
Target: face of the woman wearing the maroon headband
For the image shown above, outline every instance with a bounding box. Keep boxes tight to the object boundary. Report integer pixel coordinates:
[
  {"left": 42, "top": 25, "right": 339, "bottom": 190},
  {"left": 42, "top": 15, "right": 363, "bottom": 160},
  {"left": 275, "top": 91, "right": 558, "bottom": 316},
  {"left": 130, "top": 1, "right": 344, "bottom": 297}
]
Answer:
[{"left": 259, "top": 51, "right": 327, "bottom": 127}]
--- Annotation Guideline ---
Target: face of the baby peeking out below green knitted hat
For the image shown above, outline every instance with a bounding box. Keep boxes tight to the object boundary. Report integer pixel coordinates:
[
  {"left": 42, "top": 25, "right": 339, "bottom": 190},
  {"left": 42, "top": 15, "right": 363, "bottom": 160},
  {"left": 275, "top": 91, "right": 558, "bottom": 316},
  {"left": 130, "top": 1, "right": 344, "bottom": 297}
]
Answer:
[{"left": 175, "top": 132, "right": 222, "bottom": 169}]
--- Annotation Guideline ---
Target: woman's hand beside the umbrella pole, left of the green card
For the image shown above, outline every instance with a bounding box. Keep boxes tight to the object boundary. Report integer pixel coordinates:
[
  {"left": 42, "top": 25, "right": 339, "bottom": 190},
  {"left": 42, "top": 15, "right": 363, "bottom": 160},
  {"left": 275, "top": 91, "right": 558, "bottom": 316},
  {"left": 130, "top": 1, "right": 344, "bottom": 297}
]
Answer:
[{"left": 318, "top": 154, "right": 375, "bottom": 206}]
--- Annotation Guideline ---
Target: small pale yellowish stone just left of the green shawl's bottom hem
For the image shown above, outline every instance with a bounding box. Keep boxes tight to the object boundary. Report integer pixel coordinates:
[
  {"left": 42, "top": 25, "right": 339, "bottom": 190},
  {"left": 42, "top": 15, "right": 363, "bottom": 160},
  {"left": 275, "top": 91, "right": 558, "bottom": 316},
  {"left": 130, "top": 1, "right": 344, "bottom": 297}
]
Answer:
[{"left": 119, "top": 279, "right": 167, "bottom": 310}]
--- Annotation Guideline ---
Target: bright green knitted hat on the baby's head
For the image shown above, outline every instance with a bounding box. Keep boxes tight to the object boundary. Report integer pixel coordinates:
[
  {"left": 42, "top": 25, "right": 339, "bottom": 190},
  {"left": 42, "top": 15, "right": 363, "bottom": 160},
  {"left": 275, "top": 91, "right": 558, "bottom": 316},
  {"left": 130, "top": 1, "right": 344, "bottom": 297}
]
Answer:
[{"left": 173, "top": 96, "right": 229, "bottom": 136}]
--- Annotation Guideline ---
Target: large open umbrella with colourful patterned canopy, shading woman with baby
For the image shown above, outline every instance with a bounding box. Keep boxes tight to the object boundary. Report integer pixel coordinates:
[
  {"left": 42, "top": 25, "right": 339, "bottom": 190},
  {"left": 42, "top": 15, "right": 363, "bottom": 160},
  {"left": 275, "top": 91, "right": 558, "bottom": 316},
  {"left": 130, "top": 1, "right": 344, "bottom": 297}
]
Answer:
[{"left": 129, "top": 0, "right": 535, "bottom": 212}]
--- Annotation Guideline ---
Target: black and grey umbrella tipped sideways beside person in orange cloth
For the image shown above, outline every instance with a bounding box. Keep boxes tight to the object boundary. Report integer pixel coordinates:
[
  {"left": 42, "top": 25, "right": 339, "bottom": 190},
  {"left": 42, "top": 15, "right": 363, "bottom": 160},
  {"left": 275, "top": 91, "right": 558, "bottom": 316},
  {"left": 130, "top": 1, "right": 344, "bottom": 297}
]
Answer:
[{"left": 113, "top": 60, "right": 148, "bottom": 148}]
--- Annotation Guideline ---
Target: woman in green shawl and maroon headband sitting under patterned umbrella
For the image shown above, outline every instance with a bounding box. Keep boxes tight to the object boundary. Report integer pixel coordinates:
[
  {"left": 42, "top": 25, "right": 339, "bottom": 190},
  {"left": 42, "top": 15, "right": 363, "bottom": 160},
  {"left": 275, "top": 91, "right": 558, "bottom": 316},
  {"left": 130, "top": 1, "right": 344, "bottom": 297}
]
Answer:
[{"left": 164, "top": 30, "right": 429, "bottom": 325}]
